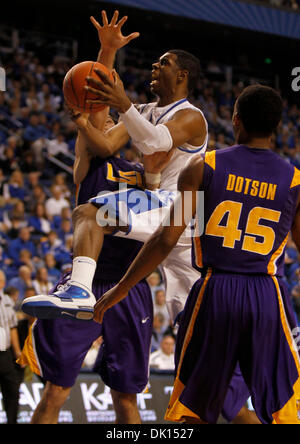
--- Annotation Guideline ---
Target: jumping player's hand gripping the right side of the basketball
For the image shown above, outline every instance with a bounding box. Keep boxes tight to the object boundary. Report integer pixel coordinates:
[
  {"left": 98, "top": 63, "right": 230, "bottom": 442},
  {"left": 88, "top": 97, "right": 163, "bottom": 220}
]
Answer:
[{"left": 85, "top": 68, "right": 131, "bottom": 113}]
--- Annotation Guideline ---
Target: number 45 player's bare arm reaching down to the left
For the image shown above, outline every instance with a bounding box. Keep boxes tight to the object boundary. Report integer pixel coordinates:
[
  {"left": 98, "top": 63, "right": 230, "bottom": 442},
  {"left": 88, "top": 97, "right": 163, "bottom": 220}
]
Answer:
[{"left": 94, "top": 156, "right": 204, "bottom": 323}]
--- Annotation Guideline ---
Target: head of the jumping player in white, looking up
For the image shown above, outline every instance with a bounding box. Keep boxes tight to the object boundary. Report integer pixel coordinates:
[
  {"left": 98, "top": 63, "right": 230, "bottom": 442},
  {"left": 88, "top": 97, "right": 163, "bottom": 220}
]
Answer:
[{"left": 150, "top": 49, "right": 200, "bottom": 96}]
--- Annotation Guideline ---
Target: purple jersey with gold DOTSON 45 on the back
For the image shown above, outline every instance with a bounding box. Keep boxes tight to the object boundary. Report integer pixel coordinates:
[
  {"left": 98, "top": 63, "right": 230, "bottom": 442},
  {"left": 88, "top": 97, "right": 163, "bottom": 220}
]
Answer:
[{"left": 192, "top": 145, "right": 300, "bottom": 276}]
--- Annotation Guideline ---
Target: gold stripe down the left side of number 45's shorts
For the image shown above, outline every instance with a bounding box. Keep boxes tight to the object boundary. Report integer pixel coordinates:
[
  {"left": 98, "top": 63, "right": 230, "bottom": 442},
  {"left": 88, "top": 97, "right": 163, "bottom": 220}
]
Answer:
[{"left": 165, "top": 269, "right": 212, "bottom": 422}]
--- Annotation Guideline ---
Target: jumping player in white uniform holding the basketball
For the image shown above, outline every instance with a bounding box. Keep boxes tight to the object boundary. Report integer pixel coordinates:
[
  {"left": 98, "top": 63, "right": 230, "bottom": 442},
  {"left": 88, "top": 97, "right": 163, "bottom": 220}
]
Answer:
[{"left": 23, "top": 50, "right": 208, "bottom": 319}]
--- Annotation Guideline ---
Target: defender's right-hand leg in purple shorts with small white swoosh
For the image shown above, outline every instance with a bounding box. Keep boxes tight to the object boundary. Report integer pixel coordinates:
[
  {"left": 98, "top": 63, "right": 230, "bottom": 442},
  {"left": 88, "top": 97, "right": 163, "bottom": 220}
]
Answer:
[{"left": 94, "top": 280, "right": 153, "bottom": 424}]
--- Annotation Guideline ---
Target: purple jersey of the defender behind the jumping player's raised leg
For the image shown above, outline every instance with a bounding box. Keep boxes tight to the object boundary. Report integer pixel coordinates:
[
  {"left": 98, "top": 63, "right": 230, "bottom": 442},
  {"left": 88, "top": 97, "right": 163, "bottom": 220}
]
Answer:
[{"left": 77, "top": 157, "right": 143, "bottom": 281}]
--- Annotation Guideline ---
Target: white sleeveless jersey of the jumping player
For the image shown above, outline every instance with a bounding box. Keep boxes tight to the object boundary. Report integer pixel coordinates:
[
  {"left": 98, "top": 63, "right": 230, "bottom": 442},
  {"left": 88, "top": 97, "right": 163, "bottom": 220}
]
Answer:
[{"left": 139, "top": 99, "right": 208, "bottom": 191}]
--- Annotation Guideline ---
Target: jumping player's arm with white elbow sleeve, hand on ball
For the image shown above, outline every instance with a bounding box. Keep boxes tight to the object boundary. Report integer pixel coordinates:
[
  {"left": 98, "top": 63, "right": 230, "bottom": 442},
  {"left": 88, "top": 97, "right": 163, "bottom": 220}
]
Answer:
[{"left": 85, "top": 69, "right": 207, "bottom": 155}]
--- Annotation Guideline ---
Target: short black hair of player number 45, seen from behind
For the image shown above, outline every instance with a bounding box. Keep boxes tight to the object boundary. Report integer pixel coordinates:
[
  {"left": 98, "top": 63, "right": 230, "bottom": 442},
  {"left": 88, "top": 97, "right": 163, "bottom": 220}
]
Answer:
[{"left": 236, "top": 84, "right": 283, "bottom": 137}]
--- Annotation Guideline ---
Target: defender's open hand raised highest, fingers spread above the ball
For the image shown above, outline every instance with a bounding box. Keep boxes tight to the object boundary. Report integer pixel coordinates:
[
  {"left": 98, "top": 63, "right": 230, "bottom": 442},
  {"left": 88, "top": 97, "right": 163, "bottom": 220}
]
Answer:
[{"left": 90, "top": 11, "right": 140, "bottom": 51}]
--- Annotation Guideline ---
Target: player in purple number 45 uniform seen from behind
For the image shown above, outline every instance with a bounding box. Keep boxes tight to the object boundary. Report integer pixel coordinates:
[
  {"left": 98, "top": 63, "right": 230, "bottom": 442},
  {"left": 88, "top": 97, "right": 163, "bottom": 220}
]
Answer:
[{"left": 95, "top": 85, "right": 300, "bottom": 424}]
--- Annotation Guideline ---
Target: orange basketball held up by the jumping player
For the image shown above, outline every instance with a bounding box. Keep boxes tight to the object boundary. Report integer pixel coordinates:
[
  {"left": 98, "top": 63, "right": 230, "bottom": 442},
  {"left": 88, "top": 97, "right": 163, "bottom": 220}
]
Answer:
[{"left": 63, "top": 61, "right": 113, "bottom": 113}]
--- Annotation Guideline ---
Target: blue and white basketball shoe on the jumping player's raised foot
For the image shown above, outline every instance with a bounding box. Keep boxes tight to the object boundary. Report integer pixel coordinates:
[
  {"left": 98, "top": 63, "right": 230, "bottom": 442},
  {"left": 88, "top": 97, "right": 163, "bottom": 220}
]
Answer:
[{"left": 22, "top": 281, "right": 96, "bottom": 321}]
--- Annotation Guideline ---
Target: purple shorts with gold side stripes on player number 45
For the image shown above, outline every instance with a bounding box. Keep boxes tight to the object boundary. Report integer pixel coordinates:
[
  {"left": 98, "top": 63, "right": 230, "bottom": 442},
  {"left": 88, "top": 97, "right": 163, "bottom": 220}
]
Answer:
[{"left": 166, "top": 270, "right": 300, "bottom": 424}]
